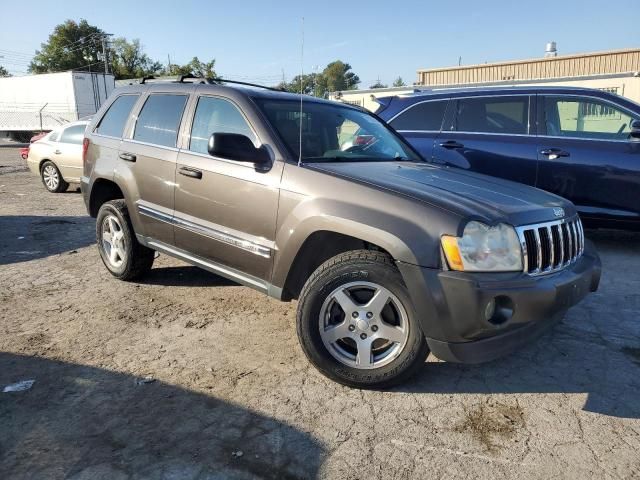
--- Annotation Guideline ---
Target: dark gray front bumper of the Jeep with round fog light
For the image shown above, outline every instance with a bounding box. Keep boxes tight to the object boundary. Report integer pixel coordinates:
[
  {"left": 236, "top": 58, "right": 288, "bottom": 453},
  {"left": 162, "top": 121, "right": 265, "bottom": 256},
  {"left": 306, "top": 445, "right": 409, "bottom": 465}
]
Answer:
[{"left": 398, "top": 241, "right": 601, "bottom": 363}]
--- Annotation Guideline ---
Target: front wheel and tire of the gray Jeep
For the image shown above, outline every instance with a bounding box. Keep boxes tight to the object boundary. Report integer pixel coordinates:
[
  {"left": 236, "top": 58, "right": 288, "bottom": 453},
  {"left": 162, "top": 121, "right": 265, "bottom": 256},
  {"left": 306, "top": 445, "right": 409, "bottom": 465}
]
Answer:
[{"left": 297, "top": 250, "right": 429, "bottom": 388}]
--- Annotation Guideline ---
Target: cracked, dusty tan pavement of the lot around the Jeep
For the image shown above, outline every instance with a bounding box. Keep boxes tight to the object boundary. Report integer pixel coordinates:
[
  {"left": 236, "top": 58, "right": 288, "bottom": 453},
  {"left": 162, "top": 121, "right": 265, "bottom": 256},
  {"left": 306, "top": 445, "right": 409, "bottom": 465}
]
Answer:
[{"left": 0, "top": 148, "right": 640, "bottom": 479}]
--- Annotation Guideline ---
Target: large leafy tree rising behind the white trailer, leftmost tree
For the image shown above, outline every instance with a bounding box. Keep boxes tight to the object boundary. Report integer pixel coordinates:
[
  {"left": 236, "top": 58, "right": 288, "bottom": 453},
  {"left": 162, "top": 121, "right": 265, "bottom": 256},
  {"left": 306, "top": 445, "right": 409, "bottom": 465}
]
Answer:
[{"left": 29, "top": 19, "right": 104, "bottom": 73}]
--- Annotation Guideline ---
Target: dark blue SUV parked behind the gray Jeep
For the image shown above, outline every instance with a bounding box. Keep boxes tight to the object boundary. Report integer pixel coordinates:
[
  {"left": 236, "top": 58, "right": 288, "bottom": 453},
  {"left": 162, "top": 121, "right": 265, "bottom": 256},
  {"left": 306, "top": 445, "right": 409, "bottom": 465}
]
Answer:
[{"left": 376, "top": 87, "right": 640, "bottom": 230}]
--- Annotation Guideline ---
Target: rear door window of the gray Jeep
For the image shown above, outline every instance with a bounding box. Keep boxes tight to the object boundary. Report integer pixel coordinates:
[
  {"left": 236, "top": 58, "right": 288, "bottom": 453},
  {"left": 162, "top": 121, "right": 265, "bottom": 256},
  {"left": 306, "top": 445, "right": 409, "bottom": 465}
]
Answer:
[{"left": 133, "top": 95, "right": 187, "bottom": 147}]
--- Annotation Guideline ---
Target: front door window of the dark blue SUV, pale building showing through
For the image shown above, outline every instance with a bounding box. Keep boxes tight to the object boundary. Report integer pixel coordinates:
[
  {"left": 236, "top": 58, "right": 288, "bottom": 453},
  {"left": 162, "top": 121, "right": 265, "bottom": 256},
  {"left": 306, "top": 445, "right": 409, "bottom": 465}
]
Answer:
[{"left": 544, "top": 97, "right": 634, "bottom": 140}]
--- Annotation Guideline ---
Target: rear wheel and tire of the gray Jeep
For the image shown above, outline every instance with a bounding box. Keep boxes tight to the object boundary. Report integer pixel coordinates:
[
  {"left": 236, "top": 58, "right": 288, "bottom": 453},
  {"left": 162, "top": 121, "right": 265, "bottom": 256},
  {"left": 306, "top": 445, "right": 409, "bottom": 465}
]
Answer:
[{"left": 96, "top": 200, "right": 155, "bottom": 280}]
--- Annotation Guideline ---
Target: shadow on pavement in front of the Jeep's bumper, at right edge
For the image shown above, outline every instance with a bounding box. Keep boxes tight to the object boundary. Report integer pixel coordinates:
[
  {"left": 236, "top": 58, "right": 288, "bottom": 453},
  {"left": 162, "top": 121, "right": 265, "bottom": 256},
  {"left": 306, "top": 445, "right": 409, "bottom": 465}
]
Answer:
[{"left": 397, "top": 230, "right": 640, "bottom": 418}]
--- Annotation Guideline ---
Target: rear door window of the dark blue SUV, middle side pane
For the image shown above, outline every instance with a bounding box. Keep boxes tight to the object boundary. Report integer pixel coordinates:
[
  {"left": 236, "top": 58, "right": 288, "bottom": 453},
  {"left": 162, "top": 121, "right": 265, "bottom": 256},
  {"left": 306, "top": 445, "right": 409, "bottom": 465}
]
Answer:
[{"left": 453, "top": 97, "right": 529, "bottom": 134}]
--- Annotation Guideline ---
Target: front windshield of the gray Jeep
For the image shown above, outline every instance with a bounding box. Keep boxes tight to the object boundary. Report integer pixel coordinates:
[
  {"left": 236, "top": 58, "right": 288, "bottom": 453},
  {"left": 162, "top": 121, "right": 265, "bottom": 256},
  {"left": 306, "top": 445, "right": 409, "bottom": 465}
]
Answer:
[{"left": 256, "top": 99, "right": 421, "bottom": 162}]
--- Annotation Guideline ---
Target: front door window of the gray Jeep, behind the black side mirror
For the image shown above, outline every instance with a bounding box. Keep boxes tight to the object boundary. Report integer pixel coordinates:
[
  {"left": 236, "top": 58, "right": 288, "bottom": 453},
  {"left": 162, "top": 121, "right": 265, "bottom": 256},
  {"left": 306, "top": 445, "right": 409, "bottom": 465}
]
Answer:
[{"left": 189, "top": 97, "right": 256, "bottom": 153}]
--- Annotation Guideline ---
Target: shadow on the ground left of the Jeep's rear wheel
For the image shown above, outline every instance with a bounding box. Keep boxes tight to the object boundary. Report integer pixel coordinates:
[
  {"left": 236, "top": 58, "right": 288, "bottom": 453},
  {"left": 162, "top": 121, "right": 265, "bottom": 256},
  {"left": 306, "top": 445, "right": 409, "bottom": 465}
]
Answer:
[{"left": 0, "top": 215, "right": 95, "bottom": 265}]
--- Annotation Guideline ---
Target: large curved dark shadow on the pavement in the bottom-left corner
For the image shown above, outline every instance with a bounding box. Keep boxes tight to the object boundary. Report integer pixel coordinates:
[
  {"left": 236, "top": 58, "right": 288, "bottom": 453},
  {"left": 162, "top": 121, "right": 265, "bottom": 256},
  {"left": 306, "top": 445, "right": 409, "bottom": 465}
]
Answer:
[{"left": 0, "top": 353, "right": 325, "bottom": 480}]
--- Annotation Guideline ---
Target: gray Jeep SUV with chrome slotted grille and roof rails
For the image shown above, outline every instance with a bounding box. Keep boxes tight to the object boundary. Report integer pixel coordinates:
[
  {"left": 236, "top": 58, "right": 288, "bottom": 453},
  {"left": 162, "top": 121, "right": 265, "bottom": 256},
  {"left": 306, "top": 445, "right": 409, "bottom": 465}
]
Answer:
[{"left": 82, "top": 79, "right": 600, "bottom": 387}]
